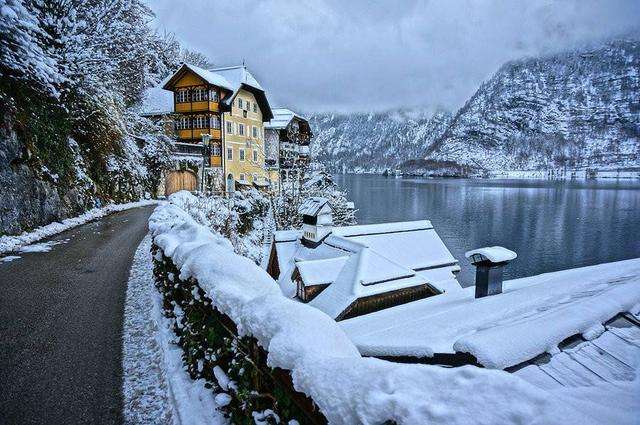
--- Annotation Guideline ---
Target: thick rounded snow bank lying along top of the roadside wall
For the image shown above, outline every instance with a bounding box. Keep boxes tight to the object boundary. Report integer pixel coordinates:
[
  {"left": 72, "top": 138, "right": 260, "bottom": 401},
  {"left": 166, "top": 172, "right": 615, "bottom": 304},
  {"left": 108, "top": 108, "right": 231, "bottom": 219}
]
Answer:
[{"left": 149, "top": 203, "right": 591, "bottom": 424}]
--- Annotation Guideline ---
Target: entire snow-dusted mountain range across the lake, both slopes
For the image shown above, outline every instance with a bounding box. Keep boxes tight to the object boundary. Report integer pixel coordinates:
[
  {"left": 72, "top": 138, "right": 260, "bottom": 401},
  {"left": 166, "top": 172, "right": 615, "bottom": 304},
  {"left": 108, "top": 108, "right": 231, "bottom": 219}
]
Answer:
[{"left": 311, "top": 39, "right": 640, "bottom": 174}]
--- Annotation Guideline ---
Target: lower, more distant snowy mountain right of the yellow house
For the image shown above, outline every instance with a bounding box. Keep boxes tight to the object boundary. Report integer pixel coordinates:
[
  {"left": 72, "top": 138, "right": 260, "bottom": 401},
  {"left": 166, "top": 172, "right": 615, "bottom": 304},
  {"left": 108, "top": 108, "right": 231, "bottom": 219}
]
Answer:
[{"left": 309, "top": 110, "right": 451, "bottom": 172}]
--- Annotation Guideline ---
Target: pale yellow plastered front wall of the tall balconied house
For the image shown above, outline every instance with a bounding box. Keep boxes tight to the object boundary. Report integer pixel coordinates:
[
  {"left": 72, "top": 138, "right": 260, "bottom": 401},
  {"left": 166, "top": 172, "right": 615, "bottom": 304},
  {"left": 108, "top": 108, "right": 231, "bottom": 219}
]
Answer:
[{"left": 223, "top": 89, "right": 267, "bottom": 183}]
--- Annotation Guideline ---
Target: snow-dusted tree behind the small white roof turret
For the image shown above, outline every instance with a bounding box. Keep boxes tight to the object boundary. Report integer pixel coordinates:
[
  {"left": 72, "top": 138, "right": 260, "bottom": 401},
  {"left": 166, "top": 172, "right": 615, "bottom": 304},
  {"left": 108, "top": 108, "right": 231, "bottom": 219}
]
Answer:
[{"left": 274, "top": 170, "right": 356, "bottom": 229}]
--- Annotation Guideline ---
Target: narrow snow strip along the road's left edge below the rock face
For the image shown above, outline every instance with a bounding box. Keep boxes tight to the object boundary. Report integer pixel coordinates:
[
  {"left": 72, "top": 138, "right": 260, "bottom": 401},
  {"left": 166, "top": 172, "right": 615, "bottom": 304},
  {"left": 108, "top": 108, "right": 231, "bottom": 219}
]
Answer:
[{"left": 0, "top": 200, "right": 157, "bottom": 254}]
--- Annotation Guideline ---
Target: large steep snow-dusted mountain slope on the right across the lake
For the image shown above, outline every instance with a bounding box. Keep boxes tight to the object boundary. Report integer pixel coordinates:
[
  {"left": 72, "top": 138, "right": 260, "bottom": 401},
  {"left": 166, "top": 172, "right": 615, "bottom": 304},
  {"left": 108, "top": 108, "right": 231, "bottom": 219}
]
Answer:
[{"left": 427, "top": 40, "right": 640, "bottom": 170}]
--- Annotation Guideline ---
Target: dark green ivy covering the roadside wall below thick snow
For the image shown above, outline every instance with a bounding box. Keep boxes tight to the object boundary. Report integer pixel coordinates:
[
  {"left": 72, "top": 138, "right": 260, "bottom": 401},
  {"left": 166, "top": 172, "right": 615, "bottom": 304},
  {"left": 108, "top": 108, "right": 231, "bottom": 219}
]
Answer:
[{"left": 152, "top": 248, "right": 324, "bottom": 424}]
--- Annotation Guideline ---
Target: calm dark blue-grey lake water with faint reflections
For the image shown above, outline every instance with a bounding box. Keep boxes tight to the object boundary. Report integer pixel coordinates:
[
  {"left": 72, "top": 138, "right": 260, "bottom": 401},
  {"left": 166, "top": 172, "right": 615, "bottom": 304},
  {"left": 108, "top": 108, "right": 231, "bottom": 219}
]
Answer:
[{"left": 336, "top": 174, "right": 640, "bottom": 286}]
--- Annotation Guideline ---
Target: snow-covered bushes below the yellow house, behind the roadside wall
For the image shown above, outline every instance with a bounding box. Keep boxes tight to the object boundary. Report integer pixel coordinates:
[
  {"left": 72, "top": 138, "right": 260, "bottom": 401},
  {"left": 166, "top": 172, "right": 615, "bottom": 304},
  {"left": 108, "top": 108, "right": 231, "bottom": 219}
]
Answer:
[{"left": 169, "top": 189, "right": 270, "bottom": 263}]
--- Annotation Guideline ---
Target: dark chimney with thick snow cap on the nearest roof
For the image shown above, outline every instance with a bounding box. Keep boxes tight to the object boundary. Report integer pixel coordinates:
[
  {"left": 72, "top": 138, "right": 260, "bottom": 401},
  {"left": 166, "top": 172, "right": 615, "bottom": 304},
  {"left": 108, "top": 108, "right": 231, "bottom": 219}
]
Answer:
[{"left": 464, "top": 246, "right": 517, "bottom": 298}]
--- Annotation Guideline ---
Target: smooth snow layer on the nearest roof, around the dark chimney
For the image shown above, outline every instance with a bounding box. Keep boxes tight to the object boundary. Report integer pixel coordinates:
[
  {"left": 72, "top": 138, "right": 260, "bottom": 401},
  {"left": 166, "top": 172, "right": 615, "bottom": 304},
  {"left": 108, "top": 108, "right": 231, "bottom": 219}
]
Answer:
[{"left": 341, "top": 259, "right": 640, "bottom": 369}]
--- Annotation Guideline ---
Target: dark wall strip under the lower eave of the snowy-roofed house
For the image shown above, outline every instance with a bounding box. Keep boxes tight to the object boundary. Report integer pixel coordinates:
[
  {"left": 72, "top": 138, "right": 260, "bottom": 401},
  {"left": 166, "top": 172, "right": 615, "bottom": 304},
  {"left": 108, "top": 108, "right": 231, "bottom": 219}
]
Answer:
[{"left": 336, "top": 285, "right": 438, "bottom": 321}]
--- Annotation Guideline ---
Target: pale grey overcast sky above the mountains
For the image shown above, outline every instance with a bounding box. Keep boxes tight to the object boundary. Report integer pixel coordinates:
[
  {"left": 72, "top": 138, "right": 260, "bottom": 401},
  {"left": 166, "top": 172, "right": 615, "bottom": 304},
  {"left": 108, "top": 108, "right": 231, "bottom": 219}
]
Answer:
[{"left": 147, "top": 0, "right": 640, "bottom": 112}]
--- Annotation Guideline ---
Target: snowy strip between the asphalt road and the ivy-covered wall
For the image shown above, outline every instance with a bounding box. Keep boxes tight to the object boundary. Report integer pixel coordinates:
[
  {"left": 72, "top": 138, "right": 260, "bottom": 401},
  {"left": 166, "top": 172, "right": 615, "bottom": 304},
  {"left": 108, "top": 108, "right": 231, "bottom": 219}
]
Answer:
[{"left": 123, "top": 236, "right": 227, "bottom": 425}]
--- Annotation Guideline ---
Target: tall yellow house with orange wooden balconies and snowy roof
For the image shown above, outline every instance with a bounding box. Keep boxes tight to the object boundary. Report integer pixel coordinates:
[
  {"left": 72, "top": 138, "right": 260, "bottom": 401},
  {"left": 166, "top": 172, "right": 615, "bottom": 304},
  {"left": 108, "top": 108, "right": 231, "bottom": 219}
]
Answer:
[{"left": 163, "top": 64, "right": 273, "bottom": 191}]
